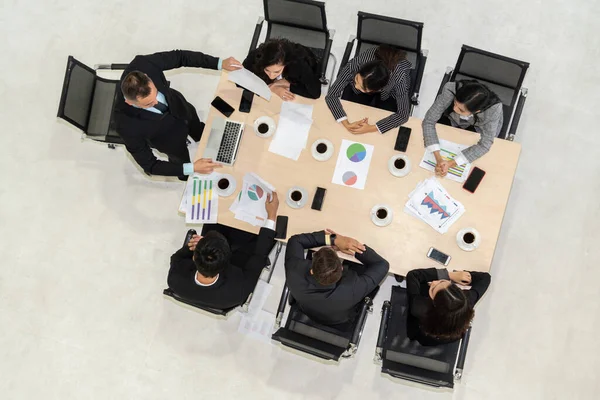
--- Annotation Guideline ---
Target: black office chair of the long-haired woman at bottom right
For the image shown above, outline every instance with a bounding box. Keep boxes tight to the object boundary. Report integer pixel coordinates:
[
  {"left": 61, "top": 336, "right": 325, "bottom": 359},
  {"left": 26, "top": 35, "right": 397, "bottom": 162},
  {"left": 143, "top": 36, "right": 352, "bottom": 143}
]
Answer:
[{"left": 375, "top": 286, "right": 471, "bottom": 388}]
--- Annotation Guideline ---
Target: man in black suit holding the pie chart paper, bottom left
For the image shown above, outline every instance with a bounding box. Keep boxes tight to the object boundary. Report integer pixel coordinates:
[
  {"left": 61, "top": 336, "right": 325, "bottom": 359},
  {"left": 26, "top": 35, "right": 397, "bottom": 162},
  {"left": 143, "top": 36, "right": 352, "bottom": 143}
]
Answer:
[{"left": 167, "top": 192, "right": 279, "bottom": 309}]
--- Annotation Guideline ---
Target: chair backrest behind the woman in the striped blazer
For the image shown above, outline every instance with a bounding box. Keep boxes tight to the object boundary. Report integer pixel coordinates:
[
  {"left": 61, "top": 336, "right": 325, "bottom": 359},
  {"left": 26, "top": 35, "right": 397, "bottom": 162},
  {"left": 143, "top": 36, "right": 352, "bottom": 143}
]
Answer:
[{"left": 356, "top": 11, "right": 423, "bottom": 93}]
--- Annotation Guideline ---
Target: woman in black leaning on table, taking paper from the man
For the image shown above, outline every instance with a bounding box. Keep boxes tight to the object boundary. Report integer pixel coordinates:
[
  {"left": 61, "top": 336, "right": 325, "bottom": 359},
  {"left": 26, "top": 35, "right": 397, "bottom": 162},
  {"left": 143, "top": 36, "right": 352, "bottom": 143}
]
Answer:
[{"left": 243, "top": 39, "right": 321, "bottom": 100}]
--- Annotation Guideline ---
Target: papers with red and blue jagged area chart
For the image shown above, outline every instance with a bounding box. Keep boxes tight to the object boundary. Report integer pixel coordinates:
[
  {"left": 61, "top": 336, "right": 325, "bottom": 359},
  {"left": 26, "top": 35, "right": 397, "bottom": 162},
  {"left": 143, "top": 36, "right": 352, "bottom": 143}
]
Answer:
[{"left": 404, "top": 178, "right": 465, "bottom": 233}]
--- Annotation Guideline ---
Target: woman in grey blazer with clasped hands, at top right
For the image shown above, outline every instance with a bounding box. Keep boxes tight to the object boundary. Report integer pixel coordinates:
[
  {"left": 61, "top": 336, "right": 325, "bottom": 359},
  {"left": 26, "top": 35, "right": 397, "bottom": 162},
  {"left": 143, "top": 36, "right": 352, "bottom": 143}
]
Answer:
[{"left": 423, "top": 80, "right": 503, "bottom": 176}]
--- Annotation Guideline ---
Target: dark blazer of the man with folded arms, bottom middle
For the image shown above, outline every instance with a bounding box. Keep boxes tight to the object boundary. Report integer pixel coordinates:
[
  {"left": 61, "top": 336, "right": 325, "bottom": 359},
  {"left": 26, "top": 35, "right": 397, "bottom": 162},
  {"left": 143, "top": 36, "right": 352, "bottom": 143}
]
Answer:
[{"left": 285, "top": 231, "right": 389, "bottom": 325}]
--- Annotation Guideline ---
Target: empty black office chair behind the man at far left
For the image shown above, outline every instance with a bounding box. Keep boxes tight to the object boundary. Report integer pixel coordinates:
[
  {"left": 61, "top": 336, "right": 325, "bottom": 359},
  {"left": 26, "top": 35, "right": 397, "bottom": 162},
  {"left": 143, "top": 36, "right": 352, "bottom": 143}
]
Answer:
[{"left": 57, "top": 56, "right": 127, "bottom": 149}]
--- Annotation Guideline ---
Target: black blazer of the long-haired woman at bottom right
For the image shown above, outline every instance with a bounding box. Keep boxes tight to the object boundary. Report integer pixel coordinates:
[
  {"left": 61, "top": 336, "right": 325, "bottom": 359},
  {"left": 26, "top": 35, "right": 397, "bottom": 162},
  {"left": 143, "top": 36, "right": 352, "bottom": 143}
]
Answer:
[{"left": 406, "top": 268, "right": 492, "bottom": 346}]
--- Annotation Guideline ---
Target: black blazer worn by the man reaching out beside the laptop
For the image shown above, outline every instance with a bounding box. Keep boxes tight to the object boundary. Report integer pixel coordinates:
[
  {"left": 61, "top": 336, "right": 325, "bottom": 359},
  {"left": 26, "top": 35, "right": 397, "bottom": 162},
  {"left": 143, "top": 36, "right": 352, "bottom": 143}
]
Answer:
[{"left": 115, "top": 50, "right": 219, "bottom": 176}]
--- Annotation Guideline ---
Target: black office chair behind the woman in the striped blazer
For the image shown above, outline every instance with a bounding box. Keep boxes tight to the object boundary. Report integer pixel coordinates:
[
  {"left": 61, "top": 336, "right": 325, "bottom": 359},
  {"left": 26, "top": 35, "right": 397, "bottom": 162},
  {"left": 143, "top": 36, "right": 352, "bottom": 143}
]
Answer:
[{"left": 338, "top": 11, "right": 428, "bottom": 113}]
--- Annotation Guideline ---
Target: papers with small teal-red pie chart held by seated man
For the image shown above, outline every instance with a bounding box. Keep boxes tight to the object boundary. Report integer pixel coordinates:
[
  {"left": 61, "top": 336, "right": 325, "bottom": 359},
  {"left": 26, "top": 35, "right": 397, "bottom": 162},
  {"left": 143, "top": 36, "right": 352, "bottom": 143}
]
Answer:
[{"left": 229, "top": 173, "right": 275, "bottom": 226}]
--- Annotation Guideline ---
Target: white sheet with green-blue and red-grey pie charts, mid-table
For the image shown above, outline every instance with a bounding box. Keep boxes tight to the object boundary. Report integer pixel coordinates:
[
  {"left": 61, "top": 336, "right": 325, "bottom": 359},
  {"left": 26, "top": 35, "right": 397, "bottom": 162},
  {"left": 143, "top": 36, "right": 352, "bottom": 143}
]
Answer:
[{"left": 331, "top": 140, "right": 375, "bottom": 189}]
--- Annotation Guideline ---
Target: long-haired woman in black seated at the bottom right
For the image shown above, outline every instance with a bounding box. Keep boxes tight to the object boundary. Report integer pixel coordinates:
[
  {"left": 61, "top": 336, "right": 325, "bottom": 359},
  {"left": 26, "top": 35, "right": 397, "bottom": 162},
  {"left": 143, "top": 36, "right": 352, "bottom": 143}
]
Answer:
[{"left": 406, "top": 268, "right": 491, "bottom": 346}]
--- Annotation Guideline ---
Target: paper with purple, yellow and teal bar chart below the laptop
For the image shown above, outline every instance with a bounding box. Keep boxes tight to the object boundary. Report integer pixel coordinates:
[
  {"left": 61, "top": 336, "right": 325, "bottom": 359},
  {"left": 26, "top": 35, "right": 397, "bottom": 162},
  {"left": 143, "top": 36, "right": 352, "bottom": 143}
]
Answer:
[{"left": 185, "top": 174, "right": 219, "bottom": 224}]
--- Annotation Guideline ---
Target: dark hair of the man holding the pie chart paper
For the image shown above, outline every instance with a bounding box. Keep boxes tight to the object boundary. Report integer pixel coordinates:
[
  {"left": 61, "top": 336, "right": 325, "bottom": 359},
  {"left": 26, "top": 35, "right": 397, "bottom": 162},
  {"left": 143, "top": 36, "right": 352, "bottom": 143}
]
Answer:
[{"left": 194, "top": 231, "right": 231, "bottom": 278}]
